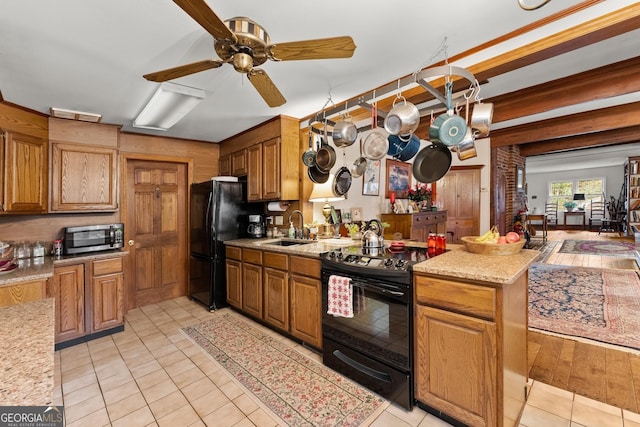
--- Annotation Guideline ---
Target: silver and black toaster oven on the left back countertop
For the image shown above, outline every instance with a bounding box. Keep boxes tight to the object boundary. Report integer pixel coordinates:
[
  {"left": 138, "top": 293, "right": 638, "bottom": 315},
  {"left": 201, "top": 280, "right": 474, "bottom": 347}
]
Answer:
[{"left": 63, "top": 224, "right": 124, "bottom": 255}]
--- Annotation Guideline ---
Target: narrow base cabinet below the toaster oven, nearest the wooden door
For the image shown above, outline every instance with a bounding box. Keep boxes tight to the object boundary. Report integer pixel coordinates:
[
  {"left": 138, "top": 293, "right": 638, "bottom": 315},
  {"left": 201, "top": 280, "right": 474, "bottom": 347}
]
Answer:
[{"left": 91, "top": 258, "right": 124, "bottom": 332}]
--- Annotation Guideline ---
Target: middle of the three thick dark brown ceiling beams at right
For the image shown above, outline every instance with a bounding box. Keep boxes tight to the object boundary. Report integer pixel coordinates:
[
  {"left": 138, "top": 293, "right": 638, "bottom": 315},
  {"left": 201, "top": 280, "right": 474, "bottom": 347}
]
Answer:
[{"left": 490, "top": 102, "right": 640, "bottom": 148}]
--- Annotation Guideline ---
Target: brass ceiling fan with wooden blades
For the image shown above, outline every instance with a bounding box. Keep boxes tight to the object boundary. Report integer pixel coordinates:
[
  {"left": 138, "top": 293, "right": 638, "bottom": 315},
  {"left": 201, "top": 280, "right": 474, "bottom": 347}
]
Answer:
[{"left": 143, "top": 0, "right": 356, "bottom": 107}]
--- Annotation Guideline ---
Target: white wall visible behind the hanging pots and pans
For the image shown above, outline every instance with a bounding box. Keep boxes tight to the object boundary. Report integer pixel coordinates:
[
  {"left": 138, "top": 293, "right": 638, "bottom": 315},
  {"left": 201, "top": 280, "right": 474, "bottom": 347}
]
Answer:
[{"left": 307, "top": 133, "right": 491, "bottom": 231}]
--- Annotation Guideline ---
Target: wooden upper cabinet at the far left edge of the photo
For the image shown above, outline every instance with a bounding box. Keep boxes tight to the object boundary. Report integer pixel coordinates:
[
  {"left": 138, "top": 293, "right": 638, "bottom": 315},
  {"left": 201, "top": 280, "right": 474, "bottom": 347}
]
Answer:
[{"left": 0, "top": 103, "right": 49, "bottom": 215}]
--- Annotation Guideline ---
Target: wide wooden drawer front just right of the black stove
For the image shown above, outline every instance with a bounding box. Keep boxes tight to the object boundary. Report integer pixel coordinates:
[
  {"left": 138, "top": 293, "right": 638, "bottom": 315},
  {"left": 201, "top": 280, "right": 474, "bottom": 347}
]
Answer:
[{"left": 414, "top": 275, "right": 497, "bottom": 320}]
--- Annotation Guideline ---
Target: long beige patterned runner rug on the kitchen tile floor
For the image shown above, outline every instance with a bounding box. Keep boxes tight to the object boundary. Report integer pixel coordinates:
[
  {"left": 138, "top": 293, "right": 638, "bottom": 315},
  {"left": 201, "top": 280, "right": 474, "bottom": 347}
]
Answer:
[{"left": 183, "top": 313, "right": 388, "bottom": 427}]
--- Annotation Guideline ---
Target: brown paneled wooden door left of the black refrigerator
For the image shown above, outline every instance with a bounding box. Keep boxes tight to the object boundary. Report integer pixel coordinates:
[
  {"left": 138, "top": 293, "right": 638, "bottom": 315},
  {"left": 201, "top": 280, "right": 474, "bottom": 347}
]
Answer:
[{"left": 125, "top": 159, "right": 189, "bottom": 308}]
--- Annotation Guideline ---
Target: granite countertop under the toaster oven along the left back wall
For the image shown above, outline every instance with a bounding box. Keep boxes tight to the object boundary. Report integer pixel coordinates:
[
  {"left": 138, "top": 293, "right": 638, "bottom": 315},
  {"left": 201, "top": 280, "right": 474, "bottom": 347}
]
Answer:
[{"left": 0, "top": 250, "right": 129, "bottom": 287}]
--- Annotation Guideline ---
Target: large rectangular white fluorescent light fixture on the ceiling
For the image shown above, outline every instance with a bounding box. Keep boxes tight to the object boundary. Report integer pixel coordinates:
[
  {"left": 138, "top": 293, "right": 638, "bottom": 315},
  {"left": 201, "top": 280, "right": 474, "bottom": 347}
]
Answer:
[{"left": 133, "top": 83, "right": 205, "bottom": 130}]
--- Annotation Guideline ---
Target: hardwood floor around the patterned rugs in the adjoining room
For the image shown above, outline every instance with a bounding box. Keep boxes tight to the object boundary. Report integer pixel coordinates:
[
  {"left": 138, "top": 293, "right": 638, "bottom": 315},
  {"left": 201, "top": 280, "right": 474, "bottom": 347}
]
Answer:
[{"left": 528, "top": 230, "right": 640, "bottom": 413}]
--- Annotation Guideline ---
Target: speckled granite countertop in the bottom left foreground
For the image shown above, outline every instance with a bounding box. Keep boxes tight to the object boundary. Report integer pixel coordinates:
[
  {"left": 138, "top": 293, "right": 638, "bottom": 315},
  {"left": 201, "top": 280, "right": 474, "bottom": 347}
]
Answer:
[{"left": 0, "top": 298, "right": 55, "bottom": 406}]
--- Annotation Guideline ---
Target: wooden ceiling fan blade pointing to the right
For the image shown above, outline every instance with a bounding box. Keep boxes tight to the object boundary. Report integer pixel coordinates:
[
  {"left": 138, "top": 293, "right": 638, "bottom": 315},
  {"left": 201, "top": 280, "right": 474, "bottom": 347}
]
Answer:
[{"left": 269, "top": 36, "right": 356, "bottom": 61}]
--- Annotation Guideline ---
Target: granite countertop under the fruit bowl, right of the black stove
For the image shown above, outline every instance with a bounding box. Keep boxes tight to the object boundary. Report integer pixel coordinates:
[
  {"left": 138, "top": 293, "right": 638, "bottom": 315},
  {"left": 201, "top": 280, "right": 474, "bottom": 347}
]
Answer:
[{"left": 413, "top": 244, "right": 540, "bottom": 284}]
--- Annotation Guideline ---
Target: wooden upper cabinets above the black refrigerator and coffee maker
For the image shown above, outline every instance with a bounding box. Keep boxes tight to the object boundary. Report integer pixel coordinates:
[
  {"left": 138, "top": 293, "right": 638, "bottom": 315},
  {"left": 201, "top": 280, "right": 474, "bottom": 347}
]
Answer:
[{"left": 220, "top": 116, "right": 301, "bottom": 201}]
